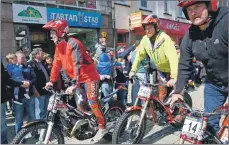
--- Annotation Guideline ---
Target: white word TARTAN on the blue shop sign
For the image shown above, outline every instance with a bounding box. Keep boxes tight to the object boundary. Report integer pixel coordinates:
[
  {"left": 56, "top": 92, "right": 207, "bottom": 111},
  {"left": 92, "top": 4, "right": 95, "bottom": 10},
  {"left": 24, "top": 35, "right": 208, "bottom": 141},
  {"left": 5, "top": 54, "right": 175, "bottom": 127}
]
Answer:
[{"left": 51, "top": 13, "right": 78, "bottom": 21}]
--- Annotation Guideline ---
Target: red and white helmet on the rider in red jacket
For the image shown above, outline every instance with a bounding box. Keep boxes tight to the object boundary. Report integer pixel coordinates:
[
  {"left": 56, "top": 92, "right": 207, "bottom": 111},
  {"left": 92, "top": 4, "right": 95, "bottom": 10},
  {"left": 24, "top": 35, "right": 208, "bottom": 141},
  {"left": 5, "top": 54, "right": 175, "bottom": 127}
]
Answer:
[{"left": 42, "top": 20, "right": 69, "bottom": 38}]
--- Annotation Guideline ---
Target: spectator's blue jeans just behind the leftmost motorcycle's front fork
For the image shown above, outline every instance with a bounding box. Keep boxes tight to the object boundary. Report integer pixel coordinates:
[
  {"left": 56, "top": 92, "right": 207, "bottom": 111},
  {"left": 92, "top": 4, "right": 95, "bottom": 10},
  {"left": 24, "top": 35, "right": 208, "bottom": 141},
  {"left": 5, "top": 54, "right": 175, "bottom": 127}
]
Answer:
[{"left": 35, "top": 95, "right": 49, "bottom": 119}]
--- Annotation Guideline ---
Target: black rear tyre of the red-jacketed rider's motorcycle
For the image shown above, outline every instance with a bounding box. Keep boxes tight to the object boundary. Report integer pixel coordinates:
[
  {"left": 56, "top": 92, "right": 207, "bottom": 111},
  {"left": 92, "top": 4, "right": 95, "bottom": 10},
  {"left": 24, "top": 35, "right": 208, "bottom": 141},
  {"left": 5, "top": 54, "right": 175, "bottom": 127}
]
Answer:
[{"left": 103, "top": 100, "right": 126, "bottom": 141}]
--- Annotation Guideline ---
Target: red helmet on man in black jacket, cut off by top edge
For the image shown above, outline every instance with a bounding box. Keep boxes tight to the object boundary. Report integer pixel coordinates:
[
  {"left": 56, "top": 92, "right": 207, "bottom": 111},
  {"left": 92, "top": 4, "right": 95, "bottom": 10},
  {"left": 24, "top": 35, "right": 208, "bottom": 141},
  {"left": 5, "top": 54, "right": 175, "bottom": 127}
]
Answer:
[{"left": 177, "top": 0, "right": 218, "bottom": 20}]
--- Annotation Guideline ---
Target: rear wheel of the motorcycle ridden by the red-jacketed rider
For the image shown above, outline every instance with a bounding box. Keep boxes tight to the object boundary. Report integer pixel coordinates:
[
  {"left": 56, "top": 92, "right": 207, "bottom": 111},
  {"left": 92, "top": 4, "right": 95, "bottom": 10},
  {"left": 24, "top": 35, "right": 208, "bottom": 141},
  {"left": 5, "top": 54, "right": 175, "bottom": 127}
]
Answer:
[{"left": 103, "top": 101, "right": 126, "bottom": 140}]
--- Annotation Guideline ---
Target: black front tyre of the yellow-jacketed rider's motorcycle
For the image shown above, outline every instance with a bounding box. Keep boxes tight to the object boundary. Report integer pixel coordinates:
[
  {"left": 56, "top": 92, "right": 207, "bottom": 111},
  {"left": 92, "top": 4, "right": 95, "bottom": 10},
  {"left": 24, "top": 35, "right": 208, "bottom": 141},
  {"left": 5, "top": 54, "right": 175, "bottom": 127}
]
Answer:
[{"left": 112, "top": 110, "right": 147, "bottom": 144}]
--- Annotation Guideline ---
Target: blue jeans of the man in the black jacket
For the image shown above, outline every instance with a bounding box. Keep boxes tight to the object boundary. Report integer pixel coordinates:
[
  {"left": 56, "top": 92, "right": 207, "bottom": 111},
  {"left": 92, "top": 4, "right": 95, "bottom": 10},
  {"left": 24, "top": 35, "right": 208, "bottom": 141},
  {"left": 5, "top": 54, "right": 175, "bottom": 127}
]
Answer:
[{"left": 204, "top": 83, "right": 228, "bottom": 132}]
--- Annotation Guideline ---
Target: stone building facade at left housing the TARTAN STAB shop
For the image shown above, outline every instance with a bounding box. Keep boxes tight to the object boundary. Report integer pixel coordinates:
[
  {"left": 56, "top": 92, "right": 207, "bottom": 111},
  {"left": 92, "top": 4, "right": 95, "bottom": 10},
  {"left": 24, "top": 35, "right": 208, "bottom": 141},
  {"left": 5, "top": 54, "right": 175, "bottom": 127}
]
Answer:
[{"left": 1, "top": 0, "right": 113, "bottom": 64}]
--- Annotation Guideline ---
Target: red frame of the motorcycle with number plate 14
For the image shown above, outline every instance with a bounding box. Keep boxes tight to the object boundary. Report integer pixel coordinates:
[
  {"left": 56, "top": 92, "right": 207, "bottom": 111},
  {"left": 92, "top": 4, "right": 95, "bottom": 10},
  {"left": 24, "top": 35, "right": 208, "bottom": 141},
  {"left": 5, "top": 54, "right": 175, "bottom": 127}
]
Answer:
[{"left": 179, "top": 103, "right": 228, "bottom": 144}]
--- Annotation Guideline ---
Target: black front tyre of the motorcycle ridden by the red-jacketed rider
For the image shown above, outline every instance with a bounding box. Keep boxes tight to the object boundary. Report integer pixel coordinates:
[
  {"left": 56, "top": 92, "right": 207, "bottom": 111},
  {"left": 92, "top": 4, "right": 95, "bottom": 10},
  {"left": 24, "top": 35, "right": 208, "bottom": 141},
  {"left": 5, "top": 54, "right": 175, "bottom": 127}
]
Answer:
[{"left": 11, "top": 123, "right": 64, "bottom": 144}]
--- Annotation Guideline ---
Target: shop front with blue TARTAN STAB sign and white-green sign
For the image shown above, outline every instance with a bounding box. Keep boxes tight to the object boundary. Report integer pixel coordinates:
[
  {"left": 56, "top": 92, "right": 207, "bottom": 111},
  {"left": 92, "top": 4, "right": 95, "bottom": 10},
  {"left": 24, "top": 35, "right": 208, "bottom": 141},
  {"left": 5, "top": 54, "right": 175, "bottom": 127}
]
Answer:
[{"left": 12, "top": 4, "right": 102, "bottom": 55}]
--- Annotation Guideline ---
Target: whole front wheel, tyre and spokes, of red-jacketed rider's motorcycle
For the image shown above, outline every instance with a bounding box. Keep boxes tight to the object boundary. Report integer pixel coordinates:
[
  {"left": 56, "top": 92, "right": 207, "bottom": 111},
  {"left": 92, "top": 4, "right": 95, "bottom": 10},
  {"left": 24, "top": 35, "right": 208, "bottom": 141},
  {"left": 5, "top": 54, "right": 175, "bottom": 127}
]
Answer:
[{"left": 12, "top": 123, "right": 64, "bottom": 144}]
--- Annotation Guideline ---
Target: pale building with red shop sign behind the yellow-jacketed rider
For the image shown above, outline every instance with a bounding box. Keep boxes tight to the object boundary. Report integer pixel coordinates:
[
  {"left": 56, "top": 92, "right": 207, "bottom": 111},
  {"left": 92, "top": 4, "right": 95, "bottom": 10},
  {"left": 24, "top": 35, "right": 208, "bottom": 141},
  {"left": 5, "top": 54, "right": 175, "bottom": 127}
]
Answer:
[{"left": 129, "top": 0, "right": 190, "bottom": 45}]
